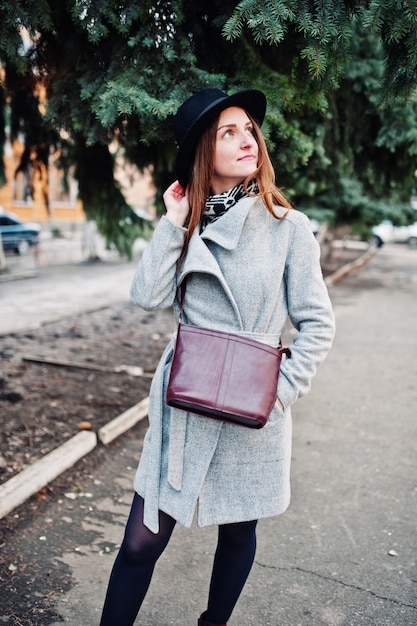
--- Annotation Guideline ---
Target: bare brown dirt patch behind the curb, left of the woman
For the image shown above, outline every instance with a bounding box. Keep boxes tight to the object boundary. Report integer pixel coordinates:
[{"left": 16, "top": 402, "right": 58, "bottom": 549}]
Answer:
[{"left": 0, "top": 304, "right": 174, "bottom": 483}]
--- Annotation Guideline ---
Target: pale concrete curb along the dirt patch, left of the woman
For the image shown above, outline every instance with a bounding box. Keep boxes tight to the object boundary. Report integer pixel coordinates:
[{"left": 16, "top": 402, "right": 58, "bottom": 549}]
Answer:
[{"left": 0, "top": 397, "right": 149, "bottom": 519}]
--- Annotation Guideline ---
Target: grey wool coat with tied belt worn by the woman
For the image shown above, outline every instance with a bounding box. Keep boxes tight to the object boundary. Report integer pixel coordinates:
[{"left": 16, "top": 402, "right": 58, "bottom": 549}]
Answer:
[{"left": 131, "top": 197, "right": 334, "bottom": 532}]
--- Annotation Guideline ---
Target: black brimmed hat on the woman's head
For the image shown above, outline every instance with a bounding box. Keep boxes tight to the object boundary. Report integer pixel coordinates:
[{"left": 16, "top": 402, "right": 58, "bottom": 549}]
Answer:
[{"left": 174, "top": 89, "right": 266, "bottom": 187}]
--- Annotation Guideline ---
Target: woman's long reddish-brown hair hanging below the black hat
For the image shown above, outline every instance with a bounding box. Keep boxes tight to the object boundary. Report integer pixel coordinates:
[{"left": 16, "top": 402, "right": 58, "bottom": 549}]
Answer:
[{"left": 180, "top": 112, "right": 292, "bottom": 260}]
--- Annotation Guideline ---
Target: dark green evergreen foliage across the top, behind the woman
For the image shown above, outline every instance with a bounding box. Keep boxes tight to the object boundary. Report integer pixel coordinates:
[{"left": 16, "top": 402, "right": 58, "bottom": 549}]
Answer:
[{"left": 0, "top": 0, "right": 417, "bottom": 255}]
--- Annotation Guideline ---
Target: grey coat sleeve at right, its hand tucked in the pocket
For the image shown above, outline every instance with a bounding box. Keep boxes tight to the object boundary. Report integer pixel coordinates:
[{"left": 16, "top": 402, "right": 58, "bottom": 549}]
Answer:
[{"left": 278, "top": 215, "right": 335, "bottom": 407}]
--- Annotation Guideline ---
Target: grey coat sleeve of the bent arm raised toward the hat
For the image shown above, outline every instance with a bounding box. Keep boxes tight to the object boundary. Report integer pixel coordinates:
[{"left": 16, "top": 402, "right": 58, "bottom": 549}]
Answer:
[{"left": 130, "top": 216, "right": 186, "bottom": 311}]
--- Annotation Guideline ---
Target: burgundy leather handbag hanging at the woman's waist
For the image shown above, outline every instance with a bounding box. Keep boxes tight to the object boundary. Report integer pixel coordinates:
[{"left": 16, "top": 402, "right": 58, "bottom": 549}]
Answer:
[{"left": 166, "top": 280, "right": 291, "bottom": 428}]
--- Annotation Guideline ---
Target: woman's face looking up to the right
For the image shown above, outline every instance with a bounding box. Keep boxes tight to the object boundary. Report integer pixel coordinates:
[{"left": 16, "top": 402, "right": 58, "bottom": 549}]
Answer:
[{"left": 211, "top": 107, "right": 258, "bottom": 193}]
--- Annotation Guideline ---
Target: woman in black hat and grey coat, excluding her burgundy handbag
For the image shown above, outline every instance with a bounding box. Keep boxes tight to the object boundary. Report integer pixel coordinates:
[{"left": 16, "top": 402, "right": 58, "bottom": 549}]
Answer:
[{"left": 101, "top": 89, "right": 334, "bottom": 626}]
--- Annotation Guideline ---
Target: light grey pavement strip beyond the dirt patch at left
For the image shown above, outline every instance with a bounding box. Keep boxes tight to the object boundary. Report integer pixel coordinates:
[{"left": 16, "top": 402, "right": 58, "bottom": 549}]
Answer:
[{"left": 0, "top": 232, "right": 146, "bottom": 336}]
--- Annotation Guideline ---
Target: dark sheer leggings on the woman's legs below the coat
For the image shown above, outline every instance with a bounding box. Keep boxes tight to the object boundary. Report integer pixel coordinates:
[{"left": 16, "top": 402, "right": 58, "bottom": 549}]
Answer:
[{"left": 100, "top": 494, "right": 257, "bottom": 626}]
